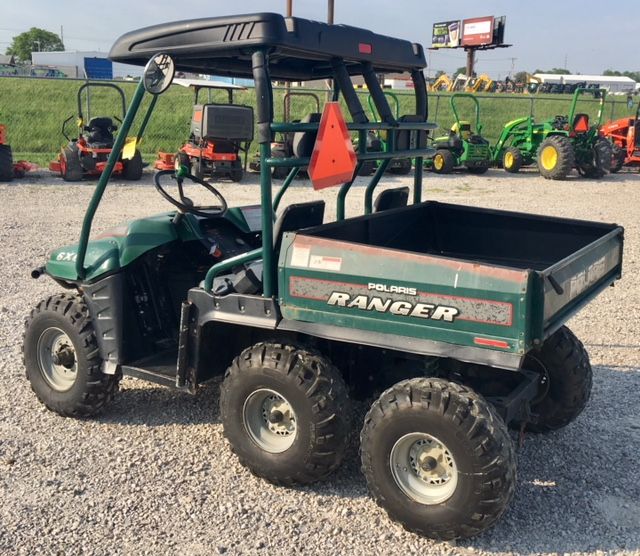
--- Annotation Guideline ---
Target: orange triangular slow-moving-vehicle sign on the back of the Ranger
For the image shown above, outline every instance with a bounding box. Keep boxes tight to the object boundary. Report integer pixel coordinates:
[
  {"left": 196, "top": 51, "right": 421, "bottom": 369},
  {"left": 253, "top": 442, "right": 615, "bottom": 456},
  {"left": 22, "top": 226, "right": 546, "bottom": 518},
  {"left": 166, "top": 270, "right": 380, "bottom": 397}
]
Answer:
[{"left": 309, "top": 102, "right": 357, "bottom": 189}]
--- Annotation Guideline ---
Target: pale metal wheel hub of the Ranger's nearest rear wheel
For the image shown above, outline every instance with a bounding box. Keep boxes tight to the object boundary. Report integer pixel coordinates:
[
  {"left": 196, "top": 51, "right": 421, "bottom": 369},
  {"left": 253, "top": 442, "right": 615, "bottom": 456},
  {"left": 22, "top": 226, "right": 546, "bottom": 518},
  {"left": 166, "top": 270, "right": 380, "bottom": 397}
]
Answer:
[{"left": 389, "top": 432, "right": 458, "bottom": 505}]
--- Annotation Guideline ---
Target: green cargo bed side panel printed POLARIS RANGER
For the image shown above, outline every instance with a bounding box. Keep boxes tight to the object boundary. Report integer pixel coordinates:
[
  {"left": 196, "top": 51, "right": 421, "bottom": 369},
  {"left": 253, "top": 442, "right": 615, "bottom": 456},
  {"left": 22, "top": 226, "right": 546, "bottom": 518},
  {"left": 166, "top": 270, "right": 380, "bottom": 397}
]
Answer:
[{"left": 279, "top": 233, "right": 530, "bottom": 353}]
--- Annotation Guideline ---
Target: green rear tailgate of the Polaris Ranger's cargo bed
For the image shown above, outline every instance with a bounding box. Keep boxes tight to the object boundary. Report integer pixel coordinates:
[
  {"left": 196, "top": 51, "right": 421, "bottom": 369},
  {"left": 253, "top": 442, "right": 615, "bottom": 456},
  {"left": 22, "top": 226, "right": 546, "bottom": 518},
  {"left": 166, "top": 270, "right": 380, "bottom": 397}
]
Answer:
[{"left": 539, "top": 227, "right": 624, "bottom": 337}]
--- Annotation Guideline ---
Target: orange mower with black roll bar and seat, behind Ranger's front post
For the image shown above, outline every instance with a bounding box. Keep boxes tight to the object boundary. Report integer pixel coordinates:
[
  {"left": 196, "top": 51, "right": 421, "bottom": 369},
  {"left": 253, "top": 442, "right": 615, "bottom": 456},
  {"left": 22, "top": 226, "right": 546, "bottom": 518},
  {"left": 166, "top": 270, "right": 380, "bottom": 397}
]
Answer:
[{"left": 49, "top": 83, "right": 143, "bottom": 181}]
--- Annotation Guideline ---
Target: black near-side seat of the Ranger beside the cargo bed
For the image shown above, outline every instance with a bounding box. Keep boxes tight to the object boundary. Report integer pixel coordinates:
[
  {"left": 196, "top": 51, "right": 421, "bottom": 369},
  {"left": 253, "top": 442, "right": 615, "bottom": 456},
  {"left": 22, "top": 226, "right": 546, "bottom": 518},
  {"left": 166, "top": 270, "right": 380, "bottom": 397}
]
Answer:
[{"left": 212, "top": 201, "right": 325, "bottom": 295}]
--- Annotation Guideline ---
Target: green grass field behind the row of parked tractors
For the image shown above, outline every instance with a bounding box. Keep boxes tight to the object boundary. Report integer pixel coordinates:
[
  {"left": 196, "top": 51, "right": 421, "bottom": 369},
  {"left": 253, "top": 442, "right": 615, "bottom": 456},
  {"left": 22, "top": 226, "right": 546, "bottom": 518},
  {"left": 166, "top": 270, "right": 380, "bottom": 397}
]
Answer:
[{"left": 0, "top": 77, "right": 630, "bottom": 166}]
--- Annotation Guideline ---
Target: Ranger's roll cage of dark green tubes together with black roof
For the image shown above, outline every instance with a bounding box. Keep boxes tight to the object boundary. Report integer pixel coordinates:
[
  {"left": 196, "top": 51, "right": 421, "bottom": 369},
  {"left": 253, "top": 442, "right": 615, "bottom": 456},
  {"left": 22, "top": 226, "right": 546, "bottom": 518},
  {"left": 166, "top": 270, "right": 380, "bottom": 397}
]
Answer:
[{"left": 76, "top": 13, "right": 436, "bottom": 298}]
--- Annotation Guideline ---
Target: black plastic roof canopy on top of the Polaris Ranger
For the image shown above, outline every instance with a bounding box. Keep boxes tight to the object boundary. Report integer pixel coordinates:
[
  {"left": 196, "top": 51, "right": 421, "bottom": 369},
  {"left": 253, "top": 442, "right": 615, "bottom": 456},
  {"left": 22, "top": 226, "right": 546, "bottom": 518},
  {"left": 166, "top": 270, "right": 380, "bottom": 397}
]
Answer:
[{"left": 109, "top": 13, "right": 426, "bottom": 81}]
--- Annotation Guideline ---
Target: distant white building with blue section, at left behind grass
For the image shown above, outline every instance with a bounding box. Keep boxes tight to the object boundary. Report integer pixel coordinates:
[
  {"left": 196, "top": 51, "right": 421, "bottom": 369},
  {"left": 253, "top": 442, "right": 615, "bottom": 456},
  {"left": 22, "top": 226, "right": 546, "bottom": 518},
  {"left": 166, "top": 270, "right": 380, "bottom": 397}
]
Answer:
[{"left": 32, "top": 50, "right": 144, "bottom": 79}]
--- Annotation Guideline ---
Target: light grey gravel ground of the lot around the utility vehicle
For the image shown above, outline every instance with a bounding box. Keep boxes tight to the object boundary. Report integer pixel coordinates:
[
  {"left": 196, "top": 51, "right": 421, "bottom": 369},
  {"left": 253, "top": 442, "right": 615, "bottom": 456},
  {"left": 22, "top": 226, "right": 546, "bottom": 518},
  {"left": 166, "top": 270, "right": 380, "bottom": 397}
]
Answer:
[{"left": 0, "top": 170, "right": 640, "bottom": 555}]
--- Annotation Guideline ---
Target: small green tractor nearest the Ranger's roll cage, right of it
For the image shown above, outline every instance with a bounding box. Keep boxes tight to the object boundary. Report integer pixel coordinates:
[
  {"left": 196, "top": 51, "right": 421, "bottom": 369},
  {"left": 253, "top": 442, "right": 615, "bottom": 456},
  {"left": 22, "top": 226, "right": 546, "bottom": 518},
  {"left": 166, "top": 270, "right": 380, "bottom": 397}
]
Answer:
[{"left": 426, "top": 93, "right": 492, "bottom": 174}]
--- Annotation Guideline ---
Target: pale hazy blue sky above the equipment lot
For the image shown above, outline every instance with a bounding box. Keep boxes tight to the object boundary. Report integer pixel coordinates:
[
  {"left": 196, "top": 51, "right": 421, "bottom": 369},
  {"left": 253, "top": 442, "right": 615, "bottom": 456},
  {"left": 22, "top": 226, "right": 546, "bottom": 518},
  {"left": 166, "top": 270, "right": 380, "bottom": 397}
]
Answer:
[{"left": 0, "top": 0, "right": 640, "bottom": 79}]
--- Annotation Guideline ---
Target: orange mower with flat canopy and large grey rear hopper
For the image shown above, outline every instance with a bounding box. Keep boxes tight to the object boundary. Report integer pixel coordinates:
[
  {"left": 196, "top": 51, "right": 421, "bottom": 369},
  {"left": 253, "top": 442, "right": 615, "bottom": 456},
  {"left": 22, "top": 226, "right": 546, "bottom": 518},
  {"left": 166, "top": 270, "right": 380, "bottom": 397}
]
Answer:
[{"left": 155, "top": 79, "right": 253, "bottom": 182}]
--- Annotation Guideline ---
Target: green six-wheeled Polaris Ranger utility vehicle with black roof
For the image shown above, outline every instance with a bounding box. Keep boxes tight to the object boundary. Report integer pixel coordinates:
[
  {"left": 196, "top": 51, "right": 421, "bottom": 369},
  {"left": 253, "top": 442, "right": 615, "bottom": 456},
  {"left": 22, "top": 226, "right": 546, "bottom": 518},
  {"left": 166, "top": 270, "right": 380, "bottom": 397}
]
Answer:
[{"left": 24, "top": 13, "right": 623, "bottom": 539}]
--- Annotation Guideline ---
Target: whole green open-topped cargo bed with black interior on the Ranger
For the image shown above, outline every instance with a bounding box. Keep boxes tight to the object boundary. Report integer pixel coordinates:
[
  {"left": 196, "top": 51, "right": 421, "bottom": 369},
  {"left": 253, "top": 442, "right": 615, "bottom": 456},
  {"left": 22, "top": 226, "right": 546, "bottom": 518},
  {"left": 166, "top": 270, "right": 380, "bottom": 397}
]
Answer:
[{"left": 279, "top": 202, "right": 623, "bottom": 367}]
